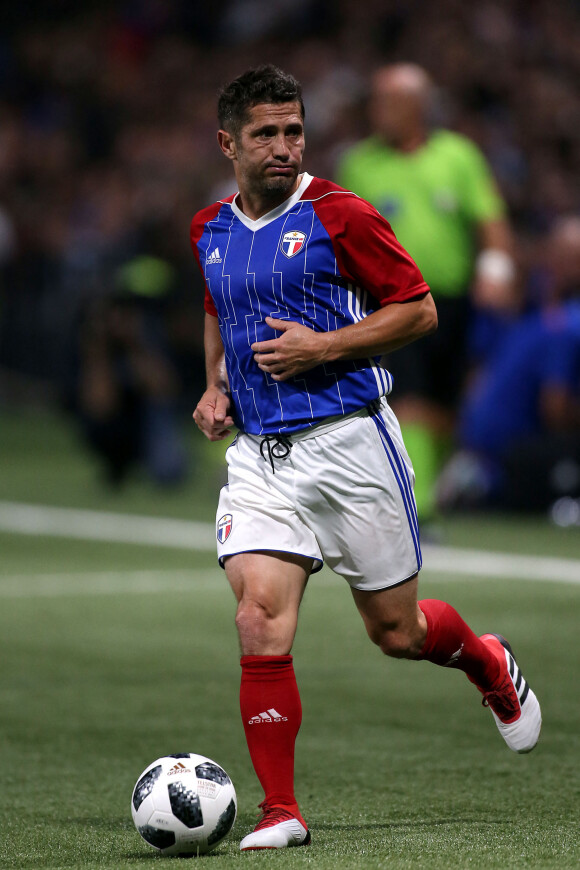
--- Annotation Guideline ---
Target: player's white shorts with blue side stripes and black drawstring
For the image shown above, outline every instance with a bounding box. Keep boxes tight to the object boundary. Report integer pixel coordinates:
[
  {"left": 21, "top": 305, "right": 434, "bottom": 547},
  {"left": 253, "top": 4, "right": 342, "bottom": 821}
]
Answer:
[{"left": 217, "top": 399, "right": 421, "bottom": 591}]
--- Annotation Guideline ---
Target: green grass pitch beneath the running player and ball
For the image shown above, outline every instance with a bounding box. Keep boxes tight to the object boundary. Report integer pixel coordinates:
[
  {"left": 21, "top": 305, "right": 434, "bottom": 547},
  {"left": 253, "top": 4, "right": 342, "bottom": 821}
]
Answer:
[{"left": 0, "top": 417, "right": 580, "bottom": 870}]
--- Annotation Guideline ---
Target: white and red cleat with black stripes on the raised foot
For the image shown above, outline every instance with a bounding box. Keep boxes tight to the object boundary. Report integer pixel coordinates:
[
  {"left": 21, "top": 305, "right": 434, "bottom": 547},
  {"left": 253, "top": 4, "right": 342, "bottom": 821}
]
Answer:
[{"left": 478, "top": 634, "right": 542, "bottom": 752}]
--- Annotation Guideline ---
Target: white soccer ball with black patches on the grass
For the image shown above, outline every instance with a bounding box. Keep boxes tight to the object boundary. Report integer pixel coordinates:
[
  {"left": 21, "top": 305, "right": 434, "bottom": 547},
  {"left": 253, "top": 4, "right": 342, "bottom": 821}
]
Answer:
[{"left": 131, "top": 752, "right": 237, "bottom": 856}]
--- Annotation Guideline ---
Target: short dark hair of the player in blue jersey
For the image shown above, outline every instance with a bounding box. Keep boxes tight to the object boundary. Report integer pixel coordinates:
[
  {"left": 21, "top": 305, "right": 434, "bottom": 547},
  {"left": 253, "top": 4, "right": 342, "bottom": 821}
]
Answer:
[{"left": 218, "top": 64, "right": 304, "bottom": 136}]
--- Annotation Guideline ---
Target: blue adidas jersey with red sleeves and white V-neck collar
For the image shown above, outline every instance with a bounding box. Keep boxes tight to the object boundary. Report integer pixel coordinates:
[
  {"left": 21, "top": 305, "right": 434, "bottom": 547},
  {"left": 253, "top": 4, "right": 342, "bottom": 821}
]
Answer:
[{"left": 191, "top": 173, "right": 429, "bottom": 435}]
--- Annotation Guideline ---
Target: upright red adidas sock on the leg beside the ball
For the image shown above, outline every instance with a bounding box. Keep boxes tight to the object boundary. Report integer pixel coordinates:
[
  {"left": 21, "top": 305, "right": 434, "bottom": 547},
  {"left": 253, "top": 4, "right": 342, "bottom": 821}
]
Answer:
[{"left": 240, "top": 656, "right": 302, "bottom": 818}]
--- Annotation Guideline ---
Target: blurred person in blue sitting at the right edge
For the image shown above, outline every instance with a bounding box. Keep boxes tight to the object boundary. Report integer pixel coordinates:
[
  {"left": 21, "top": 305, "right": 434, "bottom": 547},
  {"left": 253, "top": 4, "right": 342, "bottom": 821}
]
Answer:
[{"left": 438, "top": 216, "right": 580, "bottom": 510}]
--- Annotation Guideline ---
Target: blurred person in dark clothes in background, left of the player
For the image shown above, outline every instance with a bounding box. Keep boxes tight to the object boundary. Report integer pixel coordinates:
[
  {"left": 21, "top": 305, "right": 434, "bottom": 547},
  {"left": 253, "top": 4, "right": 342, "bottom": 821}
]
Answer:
[{"left": 71, "top": 256, "right": 187, "bottom": 486}]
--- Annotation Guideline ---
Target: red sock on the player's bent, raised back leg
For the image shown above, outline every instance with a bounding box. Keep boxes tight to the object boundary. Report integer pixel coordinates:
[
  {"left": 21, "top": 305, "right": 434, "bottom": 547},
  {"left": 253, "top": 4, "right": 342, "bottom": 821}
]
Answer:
[{"left": 419, "top": 598, "right": 499, "bottom": 689}]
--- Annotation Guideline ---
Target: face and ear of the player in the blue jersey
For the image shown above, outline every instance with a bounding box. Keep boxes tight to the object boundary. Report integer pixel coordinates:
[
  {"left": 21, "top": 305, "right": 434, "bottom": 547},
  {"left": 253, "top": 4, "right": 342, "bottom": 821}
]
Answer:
[{"left": 219, "top": 103, "right": 305, "bottom": 202}]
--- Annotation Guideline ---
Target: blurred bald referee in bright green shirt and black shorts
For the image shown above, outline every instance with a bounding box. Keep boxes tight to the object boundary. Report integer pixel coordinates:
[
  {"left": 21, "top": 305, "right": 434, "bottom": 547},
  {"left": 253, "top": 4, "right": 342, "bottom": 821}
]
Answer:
[{"left": 337, "top": 64, "right": 516, "bottom": 521}]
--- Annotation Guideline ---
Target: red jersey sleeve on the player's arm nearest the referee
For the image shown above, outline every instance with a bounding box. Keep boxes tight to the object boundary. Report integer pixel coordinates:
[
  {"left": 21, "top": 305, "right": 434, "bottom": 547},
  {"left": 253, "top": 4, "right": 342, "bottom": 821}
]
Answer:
[{"left": 313, "top": 185, "right": 429, "bottom": 306}]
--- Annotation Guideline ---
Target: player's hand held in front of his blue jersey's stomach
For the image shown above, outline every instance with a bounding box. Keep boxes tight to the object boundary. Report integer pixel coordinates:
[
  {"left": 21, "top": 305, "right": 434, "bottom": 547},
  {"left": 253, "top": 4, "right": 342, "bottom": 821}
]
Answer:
[{"left": 252, "top": 317, "right": 332, "bottom": 381}]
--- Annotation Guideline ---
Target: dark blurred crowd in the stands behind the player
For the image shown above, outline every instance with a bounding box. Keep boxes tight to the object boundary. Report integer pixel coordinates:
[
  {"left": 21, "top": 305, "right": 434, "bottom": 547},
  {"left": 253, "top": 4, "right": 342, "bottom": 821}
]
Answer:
[{"left": 0, "top": 0, "right": 580, "bottom": 516}]
